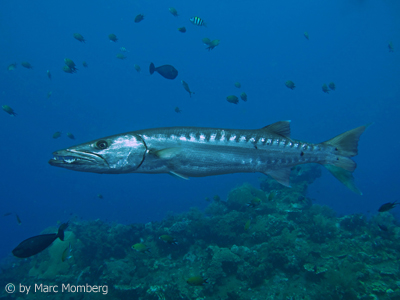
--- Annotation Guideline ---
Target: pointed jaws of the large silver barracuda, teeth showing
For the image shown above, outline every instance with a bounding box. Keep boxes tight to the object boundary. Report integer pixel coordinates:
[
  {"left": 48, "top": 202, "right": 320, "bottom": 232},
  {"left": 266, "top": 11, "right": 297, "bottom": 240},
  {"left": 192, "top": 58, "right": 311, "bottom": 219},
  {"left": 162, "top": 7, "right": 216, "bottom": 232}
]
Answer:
[{"left": 49, "top": 149, "right": 108, "bottom": 169}]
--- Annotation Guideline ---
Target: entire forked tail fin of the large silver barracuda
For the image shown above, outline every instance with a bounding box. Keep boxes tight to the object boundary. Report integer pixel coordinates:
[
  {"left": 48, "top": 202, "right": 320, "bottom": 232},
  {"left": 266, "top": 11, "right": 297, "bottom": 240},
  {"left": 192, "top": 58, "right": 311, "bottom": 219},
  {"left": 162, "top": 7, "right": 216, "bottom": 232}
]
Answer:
[{"left": 323, "top": 124, "right": 370, "bottom": 195}]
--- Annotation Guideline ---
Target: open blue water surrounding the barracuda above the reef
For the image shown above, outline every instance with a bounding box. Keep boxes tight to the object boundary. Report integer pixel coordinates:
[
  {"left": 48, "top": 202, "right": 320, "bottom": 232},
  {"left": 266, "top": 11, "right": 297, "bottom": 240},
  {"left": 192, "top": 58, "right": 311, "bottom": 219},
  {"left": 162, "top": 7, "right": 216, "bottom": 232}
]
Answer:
[{"left": 0, "top": 0, "right": 400, "bottom": 257}]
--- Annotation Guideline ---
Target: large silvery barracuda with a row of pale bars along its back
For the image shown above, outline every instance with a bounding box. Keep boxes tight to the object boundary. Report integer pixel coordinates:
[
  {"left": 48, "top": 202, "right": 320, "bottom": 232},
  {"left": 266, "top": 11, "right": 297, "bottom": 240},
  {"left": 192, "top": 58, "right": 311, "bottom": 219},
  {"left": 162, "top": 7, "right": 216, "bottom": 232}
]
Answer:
[{"left": 49, "top": 121, "right": 367, "bottom": 194}]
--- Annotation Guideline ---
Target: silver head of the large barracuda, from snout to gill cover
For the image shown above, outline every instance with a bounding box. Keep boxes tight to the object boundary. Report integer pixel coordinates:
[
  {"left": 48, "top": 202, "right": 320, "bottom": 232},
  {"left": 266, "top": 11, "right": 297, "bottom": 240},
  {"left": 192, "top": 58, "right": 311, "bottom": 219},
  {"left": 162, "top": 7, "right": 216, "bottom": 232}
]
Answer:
[{"left": 49, "top": 134, "right": 146, "bottom": 174}]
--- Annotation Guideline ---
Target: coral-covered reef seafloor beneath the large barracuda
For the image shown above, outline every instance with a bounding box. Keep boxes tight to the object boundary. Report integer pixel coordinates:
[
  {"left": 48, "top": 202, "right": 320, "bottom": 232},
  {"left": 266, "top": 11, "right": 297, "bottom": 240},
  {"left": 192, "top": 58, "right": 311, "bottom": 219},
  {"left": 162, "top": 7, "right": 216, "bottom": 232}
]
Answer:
[{"left": 0, "top": 166, "right": 400, "bottom": 300}]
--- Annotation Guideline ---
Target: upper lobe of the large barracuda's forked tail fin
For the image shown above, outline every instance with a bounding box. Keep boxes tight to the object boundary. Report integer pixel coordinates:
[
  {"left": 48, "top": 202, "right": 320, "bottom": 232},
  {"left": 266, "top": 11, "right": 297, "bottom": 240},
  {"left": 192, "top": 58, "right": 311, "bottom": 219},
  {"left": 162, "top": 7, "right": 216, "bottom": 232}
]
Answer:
[{"left": 322, "top": 123, "right": 371, "bottom": 157}]
